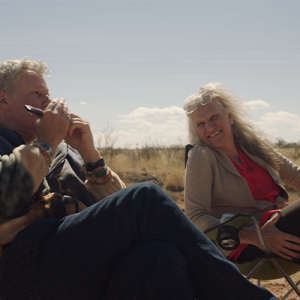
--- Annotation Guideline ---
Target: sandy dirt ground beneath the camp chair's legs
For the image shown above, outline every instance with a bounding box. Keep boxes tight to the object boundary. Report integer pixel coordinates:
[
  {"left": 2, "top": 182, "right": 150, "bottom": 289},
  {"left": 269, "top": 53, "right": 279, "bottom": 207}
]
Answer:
[{"left": 251, "top": 272, "right": 300, "bottom": 300}]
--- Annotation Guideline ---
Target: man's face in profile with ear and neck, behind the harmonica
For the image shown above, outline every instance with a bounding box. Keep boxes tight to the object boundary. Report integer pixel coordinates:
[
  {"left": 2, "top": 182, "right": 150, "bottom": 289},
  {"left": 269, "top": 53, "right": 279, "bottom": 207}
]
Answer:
[{"left": 6, "top": 71, "right": 51, "bottom": 142}]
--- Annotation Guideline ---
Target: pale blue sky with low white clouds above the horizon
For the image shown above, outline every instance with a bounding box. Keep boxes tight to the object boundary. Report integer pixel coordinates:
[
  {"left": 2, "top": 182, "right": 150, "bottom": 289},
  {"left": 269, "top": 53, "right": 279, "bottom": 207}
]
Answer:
[{"left": 0, "top": 0, "right": 300, "bottom": 148}]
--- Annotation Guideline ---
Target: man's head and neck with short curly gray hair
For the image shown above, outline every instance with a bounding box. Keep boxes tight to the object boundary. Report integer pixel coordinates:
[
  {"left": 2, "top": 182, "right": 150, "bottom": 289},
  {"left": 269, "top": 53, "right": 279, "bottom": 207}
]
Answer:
[{"left": 0, "top": 57, "right": 51, "bottom": 142}]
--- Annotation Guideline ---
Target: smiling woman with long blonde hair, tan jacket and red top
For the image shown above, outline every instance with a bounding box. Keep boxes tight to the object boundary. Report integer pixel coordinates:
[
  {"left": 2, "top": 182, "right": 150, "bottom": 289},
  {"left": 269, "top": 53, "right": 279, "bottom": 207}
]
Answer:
[{"left": 183, "top": 83, "right": 300, "bottom": 261}]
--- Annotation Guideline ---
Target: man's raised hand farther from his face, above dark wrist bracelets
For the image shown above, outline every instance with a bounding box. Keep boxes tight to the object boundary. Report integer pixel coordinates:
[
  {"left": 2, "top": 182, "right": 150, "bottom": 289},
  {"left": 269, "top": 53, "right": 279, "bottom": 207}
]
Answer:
[{"left": 65, "top": 114, "right": 100, "bottom": 163}]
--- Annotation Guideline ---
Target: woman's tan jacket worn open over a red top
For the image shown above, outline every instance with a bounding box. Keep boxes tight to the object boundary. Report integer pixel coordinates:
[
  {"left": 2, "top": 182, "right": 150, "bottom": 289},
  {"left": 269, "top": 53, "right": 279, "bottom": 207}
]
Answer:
[{"left": 184, "top": 145, "right": 300, "bottom": 231}]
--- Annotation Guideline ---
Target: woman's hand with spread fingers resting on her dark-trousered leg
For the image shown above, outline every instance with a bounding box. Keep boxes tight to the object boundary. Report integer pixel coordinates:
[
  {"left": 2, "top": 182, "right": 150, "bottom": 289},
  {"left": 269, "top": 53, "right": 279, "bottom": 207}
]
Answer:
[{"left": 262, "top": 211, "right": 300, "bottom": 260}]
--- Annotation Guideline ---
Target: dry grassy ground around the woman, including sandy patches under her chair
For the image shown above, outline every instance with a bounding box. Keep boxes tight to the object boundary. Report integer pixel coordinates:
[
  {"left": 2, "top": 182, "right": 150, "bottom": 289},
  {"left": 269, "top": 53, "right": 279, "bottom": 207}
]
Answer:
[{"left": 100, "top": 147, "right": 300, "bottom": 300}]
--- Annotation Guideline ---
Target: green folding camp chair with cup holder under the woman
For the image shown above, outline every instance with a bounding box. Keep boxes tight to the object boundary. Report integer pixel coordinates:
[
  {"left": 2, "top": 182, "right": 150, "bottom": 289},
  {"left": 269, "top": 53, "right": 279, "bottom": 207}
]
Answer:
[{"left": 205, "top": 214, "right": 300, "bottom": 300}]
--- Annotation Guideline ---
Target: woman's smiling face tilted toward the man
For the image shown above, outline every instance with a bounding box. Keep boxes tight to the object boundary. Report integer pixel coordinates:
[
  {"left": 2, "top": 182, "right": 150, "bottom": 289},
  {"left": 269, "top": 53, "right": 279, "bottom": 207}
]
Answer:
[{"left": 190, "top": 100, "right": 235, "bottom": 152}]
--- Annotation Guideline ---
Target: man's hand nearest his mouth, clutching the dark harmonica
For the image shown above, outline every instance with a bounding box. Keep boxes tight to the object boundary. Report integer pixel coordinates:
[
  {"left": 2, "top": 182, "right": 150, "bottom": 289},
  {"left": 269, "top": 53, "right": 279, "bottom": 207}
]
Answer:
[{"left": 35, "top": 99, "right": 71, "bottom": 152}]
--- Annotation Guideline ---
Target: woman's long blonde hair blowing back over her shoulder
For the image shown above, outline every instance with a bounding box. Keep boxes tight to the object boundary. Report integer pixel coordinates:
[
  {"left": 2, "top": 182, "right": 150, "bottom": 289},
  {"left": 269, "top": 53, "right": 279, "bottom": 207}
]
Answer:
[{"left": 185, "top": 82, "right": 279, "bottom": 169}]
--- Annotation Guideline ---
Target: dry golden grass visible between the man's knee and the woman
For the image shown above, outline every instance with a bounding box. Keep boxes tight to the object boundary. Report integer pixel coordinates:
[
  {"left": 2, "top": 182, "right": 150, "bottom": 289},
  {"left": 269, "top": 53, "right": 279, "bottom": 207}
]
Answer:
[{"left": 100, "top": 147, "right": 185, "bottom": 208}]
